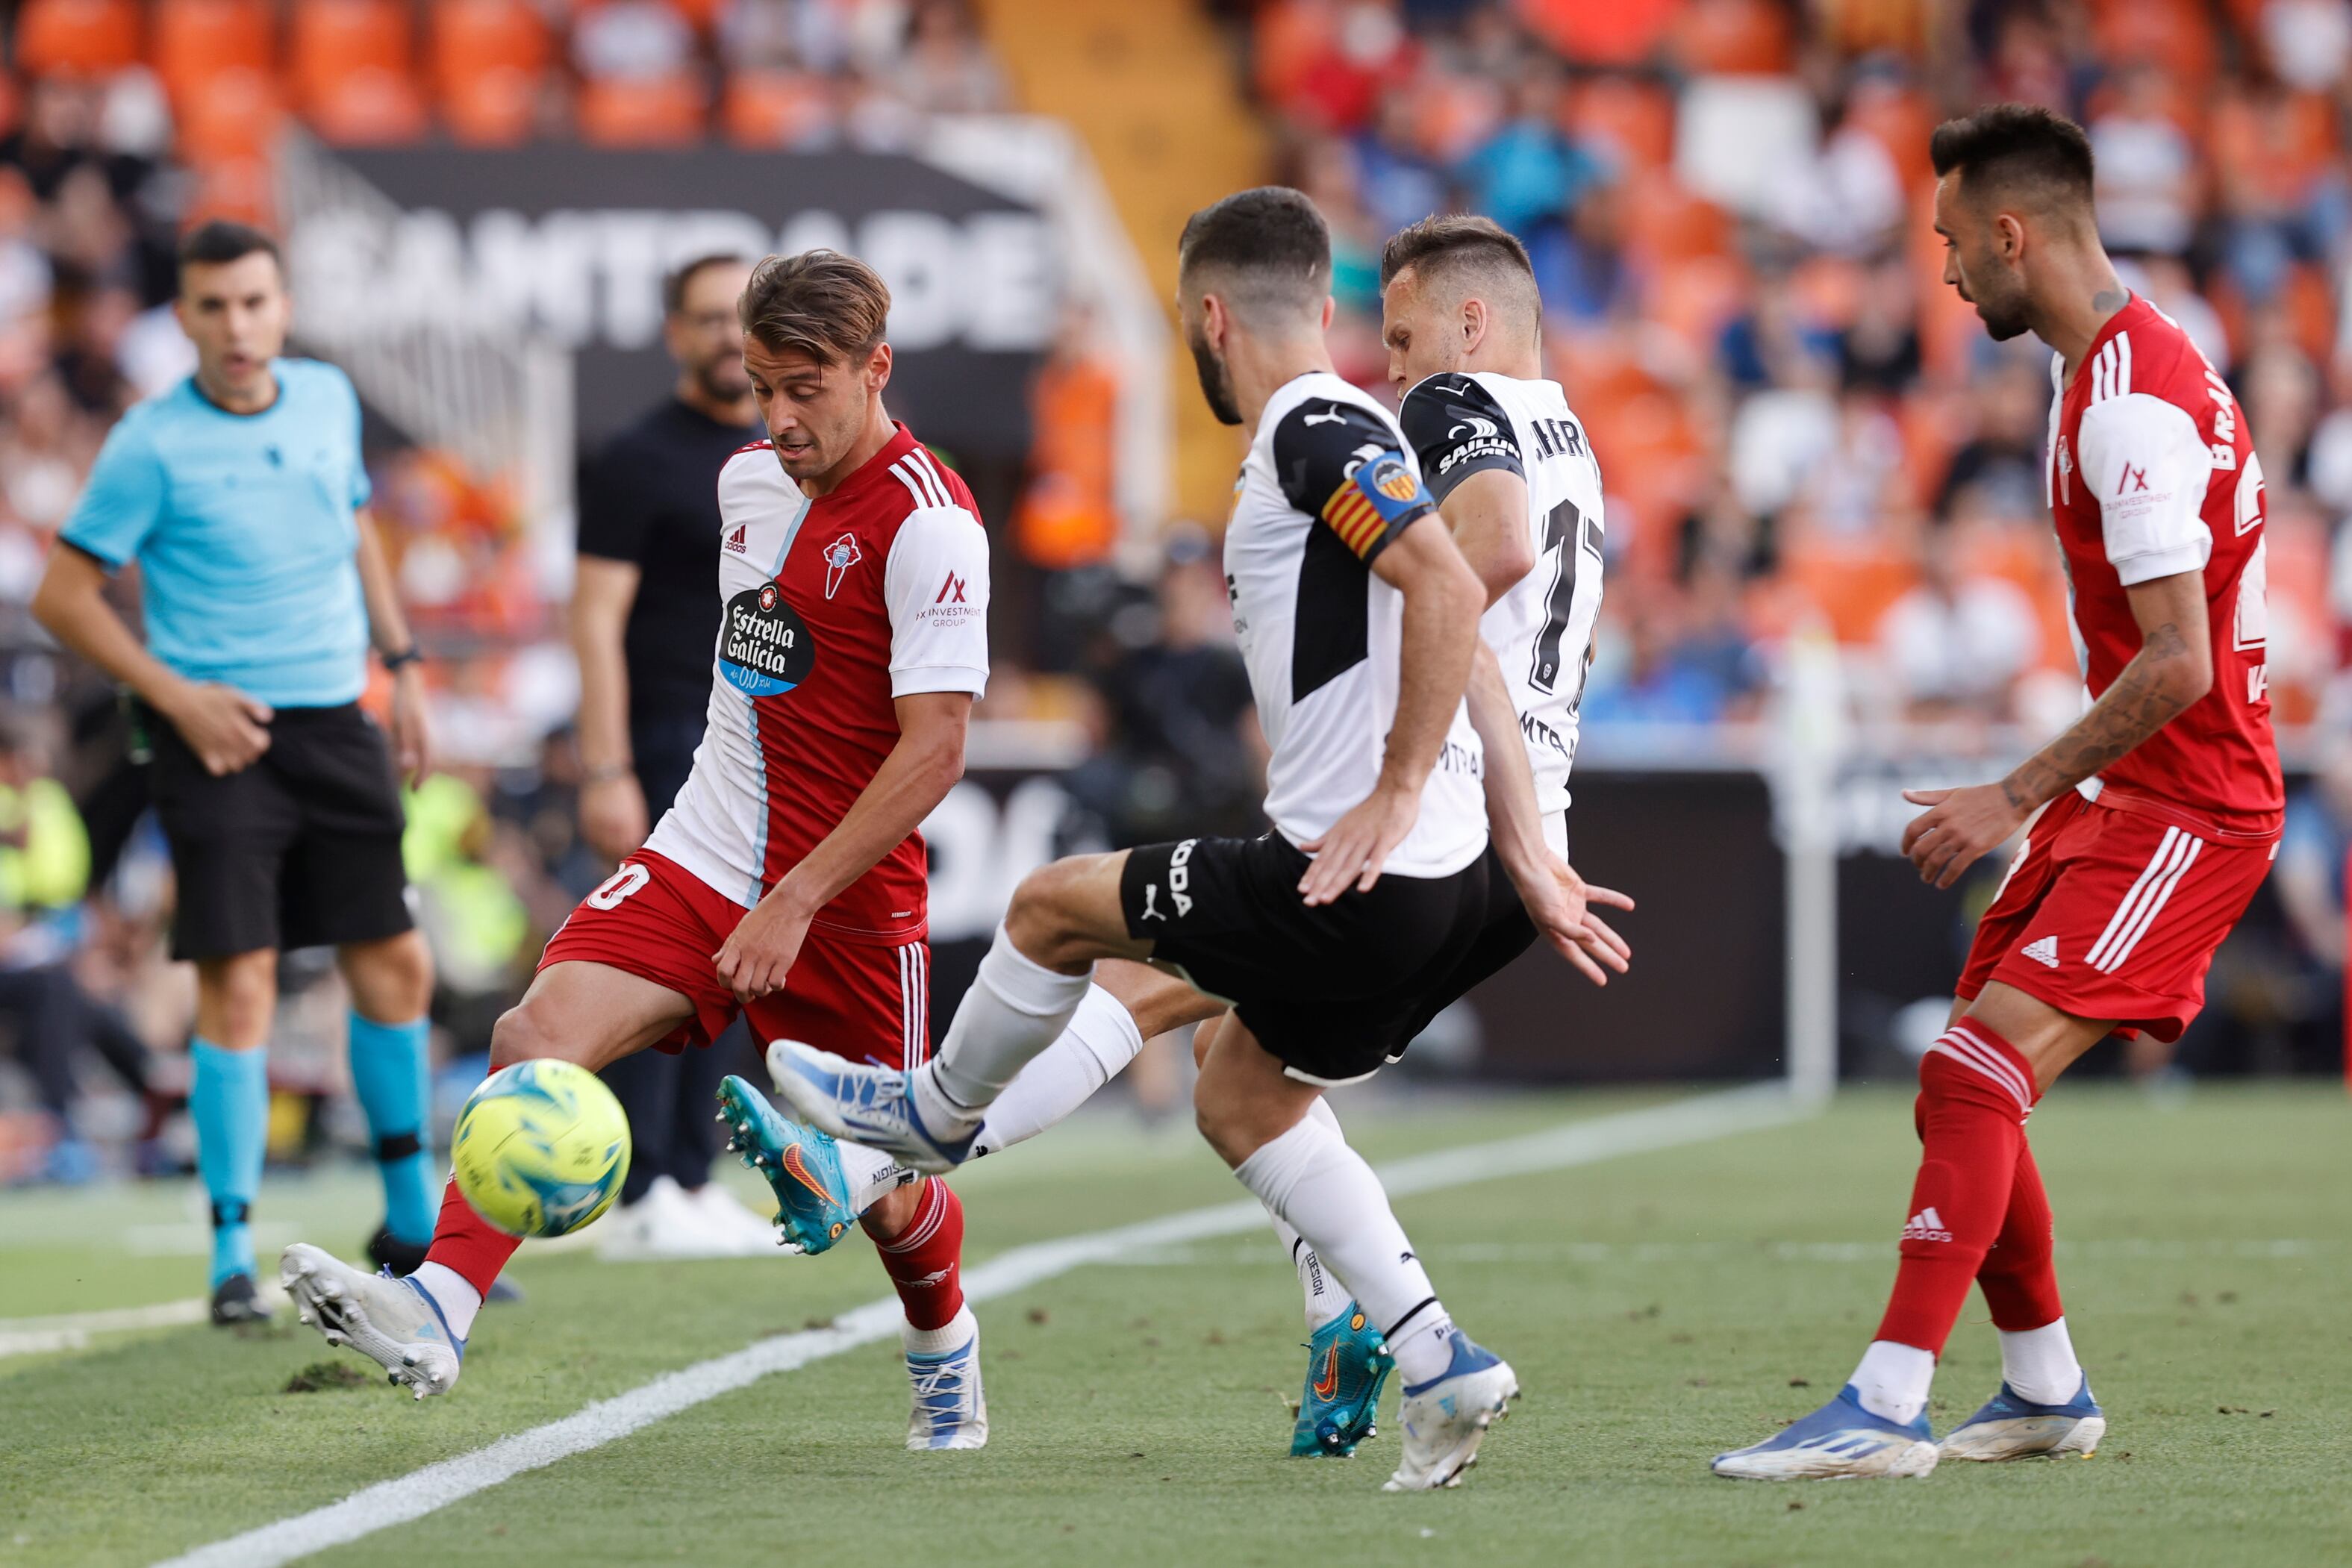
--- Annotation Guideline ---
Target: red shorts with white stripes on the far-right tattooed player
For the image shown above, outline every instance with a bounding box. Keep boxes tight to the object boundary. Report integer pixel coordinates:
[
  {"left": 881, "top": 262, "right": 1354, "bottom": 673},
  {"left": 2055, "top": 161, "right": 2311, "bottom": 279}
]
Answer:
[{"left": 1954, "top": 790, "right": 2279, "bottom": 1041}]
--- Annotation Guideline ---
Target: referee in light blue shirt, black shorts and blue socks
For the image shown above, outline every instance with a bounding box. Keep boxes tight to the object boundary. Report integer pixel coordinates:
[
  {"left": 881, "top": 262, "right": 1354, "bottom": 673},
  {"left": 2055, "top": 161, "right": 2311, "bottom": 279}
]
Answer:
[{"left": 33, "top": 223, "right": 437, "bottom": 1323}]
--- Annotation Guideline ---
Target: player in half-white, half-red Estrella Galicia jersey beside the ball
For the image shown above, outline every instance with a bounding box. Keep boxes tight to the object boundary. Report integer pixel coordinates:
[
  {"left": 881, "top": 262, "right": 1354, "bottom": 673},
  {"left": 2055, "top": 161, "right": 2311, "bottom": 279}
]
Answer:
[{"left": 282, "top": 249, "right": 1011, "bottom": 1448}]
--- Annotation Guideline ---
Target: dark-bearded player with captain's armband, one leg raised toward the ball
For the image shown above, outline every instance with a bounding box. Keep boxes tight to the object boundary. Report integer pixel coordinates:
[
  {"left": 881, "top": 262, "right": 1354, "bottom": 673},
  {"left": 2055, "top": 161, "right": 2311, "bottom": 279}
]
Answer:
[{"left": 769, "top": 188, "right": 1602, "bottom": 1490}]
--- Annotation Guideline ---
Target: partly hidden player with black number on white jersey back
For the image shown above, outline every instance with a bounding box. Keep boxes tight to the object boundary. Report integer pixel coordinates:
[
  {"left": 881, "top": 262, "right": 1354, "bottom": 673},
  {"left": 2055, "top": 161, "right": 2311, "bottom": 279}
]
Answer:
[{"left": 722, "top": 207, "right": 1630, "bottom": 1458}]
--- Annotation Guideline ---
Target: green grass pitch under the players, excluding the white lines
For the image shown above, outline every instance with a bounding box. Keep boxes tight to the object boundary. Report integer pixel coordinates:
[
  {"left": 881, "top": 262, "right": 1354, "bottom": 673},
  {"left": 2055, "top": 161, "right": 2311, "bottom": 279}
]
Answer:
[{"left": 0, "top": 1084, "right": 2352, "bottom": 1568}]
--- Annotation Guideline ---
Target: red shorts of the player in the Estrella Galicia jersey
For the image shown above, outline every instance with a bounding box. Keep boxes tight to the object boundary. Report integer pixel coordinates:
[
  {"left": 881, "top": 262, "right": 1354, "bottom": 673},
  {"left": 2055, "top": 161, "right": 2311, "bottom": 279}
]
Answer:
[{"left": 539, "top": 849, "right": 932, "bottom": 1067}]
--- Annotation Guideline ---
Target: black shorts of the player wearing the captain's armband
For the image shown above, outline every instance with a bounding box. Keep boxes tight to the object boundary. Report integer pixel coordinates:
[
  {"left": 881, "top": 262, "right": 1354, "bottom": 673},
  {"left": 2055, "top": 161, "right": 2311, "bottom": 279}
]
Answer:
[{"left": 1120, "top": 832, "right": 1533, "bottom": 1084}]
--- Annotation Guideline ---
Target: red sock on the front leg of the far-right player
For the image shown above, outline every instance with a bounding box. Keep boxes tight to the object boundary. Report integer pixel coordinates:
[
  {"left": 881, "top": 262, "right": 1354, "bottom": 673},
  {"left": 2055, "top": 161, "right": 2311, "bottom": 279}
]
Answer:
[{"left": 1872, "top": 1018, "right": 2039, "bottom": 1354}]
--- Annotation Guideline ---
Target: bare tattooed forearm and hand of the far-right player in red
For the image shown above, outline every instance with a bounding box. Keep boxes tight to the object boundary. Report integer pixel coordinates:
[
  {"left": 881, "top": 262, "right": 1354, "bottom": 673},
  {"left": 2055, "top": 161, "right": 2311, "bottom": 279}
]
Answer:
[{"left": 1903, "top": 571, "right": 2213, "bottom": 887}]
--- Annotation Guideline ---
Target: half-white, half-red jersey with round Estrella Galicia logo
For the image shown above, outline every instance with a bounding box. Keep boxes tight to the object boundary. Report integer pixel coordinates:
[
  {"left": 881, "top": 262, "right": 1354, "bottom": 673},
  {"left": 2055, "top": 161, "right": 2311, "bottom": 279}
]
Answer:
[{"left": 644, "top": 425, "right": 988, "bottom": 943}]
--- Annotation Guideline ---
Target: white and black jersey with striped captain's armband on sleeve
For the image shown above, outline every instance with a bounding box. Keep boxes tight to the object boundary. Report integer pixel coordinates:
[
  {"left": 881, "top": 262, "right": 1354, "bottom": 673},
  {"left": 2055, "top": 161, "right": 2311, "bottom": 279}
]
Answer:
[{"left": 1226, "top": 372, "right": 1486, "bottom": 877}]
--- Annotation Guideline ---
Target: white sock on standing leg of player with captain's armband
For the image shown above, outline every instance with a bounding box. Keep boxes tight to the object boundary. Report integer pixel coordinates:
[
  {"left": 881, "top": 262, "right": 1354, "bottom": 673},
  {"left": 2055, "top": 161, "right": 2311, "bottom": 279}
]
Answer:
[{"left": 1232, "top": 1116, "right": 1453, "bottom": 1382}]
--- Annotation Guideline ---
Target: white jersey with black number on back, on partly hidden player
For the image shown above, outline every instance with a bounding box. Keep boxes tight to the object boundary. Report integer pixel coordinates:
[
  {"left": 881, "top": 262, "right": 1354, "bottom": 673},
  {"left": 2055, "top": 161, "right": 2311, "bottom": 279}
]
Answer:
[{"left": 1400, "top": 372, "right": 1602, "bottom": 813}]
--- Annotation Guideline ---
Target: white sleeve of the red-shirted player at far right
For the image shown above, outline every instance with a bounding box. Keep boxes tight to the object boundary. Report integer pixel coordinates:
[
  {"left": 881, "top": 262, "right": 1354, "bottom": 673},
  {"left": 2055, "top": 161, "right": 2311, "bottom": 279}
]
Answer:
[{"left": 2077, "top": 393, "right": 2213, "bottom": 587}]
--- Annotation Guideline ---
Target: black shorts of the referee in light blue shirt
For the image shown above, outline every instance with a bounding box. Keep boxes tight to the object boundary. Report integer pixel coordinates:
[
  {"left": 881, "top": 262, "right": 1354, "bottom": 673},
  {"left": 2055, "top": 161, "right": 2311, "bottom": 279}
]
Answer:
[{"left": 139, "top": 703, "right": 414, "bottom": 959}]
